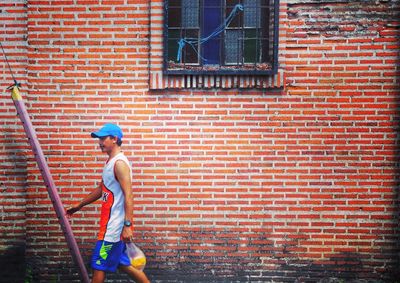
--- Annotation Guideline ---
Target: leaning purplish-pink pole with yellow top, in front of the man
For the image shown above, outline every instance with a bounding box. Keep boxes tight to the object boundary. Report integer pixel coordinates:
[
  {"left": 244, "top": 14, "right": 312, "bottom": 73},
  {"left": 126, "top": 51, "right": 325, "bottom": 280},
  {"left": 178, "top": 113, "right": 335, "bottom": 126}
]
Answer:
[{"left": 9, "top": 82, "right": 90, "bottom": 283}]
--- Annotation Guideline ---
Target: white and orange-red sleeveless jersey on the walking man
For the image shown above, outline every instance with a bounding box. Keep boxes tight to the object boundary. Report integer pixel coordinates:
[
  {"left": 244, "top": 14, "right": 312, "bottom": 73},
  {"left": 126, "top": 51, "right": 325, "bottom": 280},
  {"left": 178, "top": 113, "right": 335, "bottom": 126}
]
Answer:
[{"left": 98, "top": 152, "right": 132, "bottom": 242}]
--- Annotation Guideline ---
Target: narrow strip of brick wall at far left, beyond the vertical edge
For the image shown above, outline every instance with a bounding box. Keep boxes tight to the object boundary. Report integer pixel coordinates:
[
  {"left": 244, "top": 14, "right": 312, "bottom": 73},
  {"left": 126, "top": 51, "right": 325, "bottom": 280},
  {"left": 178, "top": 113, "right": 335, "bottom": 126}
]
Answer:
[{"left": 0, "top": 1, "right": 29, "bottom": 282}]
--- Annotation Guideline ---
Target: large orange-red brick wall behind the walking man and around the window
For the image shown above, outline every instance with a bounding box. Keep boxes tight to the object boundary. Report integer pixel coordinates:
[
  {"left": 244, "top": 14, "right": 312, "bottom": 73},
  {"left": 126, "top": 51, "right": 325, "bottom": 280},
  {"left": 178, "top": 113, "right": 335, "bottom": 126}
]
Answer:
[{"left": 0, "top": 0, "right": 400, "bottom": 282}]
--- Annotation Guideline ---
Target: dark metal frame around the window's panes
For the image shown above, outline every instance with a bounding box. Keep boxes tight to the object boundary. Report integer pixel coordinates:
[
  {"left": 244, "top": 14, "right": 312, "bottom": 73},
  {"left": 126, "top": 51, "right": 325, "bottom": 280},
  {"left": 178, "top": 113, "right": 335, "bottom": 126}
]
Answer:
[{"left": 162, "top": 0, "right": 280, "bottom": 75}]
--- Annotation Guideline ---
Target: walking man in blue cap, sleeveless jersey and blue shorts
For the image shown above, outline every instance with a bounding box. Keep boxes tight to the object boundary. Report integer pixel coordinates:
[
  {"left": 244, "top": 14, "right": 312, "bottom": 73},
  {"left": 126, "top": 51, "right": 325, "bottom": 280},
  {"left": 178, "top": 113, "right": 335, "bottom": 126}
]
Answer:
[{"left": 67, "top": 124, "right": 150, "bottom": 283}]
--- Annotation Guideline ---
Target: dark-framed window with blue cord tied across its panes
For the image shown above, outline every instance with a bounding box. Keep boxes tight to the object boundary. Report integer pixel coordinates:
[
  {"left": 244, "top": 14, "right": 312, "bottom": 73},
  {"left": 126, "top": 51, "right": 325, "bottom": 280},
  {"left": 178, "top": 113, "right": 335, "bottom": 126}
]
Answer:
[{"left": 164, "top": 0, "right": 279, "bottom": 74}]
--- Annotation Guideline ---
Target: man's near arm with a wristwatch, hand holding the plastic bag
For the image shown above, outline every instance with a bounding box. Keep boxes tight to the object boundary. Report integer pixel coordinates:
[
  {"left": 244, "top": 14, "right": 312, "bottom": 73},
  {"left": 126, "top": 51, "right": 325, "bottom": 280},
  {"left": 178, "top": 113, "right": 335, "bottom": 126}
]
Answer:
[{"left": 115, "top": 160, "right": 133, "bottom": 242}]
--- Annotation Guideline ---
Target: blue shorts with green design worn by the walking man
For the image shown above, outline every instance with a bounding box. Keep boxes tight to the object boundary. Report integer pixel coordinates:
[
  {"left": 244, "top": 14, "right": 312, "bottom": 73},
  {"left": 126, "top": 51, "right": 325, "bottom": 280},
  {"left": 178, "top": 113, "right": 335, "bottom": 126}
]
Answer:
[{"left": 91, "top": 241, "right": 130, "bottom": 272}]
